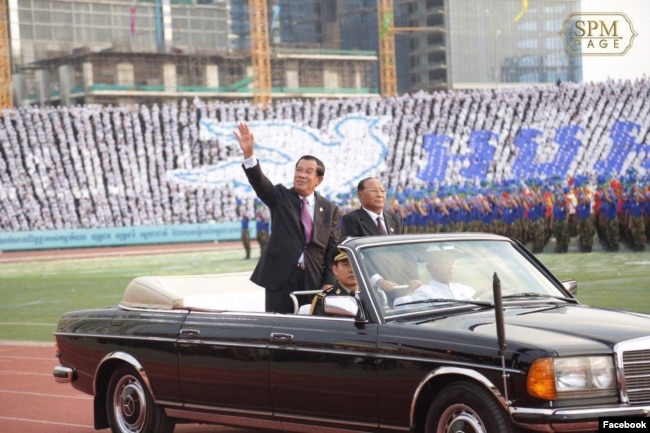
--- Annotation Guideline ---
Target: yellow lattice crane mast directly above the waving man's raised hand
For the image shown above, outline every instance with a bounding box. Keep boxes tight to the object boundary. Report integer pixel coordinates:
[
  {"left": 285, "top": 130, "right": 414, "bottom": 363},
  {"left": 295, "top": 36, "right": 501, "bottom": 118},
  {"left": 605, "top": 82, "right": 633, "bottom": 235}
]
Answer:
[{"left": 248, "top": 0, "right": 271, "bottom": 109}]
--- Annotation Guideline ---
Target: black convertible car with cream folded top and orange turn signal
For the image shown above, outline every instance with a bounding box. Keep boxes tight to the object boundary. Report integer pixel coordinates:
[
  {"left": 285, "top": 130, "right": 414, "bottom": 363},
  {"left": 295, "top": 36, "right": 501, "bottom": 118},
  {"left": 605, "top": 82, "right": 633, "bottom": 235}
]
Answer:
[{"left": 54, "top": 234, "right": 650, "bottom": 433}]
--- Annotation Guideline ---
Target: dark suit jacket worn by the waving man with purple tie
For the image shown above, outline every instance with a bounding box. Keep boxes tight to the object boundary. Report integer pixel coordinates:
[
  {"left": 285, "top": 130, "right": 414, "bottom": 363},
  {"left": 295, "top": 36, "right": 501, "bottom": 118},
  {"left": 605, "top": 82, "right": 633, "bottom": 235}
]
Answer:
[{"left": 244, "top": 162, "right": 339, "bottom": 291}]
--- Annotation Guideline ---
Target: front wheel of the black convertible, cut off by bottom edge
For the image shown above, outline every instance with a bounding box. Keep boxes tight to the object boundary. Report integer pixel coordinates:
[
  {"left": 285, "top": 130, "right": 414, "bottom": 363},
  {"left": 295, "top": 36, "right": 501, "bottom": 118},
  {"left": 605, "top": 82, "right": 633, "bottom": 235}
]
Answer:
[{"left": 424, "top": 382, "right": 514, "bottom": 433}]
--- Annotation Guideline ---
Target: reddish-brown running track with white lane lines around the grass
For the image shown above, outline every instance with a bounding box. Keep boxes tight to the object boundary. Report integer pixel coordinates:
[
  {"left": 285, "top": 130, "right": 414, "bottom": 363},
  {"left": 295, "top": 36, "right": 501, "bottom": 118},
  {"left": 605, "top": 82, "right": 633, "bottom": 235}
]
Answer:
[{"left": 0, "top": 242, "right": 274, "bottom": 433}]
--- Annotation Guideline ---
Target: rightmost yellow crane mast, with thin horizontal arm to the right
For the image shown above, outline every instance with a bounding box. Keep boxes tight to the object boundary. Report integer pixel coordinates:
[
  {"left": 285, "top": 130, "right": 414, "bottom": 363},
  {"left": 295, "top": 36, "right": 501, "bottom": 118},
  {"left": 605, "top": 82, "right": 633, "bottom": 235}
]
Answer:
[{"left": 377, "top": 0, "right": 442, "bottom": 98}]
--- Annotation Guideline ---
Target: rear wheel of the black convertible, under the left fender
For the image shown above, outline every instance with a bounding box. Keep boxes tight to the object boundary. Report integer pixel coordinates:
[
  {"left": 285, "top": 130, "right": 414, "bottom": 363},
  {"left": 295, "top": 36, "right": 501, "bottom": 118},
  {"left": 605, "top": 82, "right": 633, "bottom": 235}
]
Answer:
[{"left": 106, "top": 365, "right": 174, "bottom": 433}]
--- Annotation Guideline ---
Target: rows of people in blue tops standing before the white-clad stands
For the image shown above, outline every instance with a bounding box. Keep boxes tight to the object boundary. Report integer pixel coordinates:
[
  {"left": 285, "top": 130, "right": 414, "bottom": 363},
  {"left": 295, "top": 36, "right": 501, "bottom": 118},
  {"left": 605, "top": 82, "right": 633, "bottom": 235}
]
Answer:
[{"left": 343, "top": 169, "right": 650, "bottom": 253}]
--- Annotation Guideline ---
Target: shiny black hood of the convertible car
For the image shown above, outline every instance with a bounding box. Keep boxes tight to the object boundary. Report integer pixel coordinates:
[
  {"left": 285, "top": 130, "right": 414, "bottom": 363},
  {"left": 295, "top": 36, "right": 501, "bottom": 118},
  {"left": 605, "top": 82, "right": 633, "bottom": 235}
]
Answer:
[{"left": 421, "top": 304, "right": 650, "bottom": 356}]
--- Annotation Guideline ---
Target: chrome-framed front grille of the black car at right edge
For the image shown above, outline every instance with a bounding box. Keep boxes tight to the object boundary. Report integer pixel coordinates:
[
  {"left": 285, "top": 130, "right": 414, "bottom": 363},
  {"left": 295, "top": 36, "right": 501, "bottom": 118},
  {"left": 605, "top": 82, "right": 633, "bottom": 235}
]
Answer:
[{"left": 614, "top": 338, "right": 650, "bottom": 404}]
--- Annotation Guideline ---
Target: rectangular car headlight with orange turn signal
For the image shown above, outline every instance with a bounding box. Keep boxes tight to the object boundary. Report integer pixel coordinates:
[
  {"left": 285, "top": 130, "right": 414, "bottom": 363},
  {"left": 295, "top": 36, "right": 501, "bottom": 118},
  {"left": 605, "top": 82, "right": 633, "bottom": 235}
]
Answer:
[{"left": 527, "top": 356, "right": 617, "bottom": 400}]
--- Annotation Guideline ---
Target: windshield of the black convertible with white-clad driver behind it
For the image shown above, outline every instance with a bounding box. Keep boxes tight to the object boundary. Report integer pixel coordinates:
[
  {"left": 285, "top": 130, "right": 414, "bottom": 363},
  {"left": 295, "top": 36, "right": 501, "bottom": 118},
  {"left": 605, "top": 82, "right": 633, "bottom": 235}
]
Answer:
[{"left": 352, "top": 236, "right": 572, "bottom": 317}]
